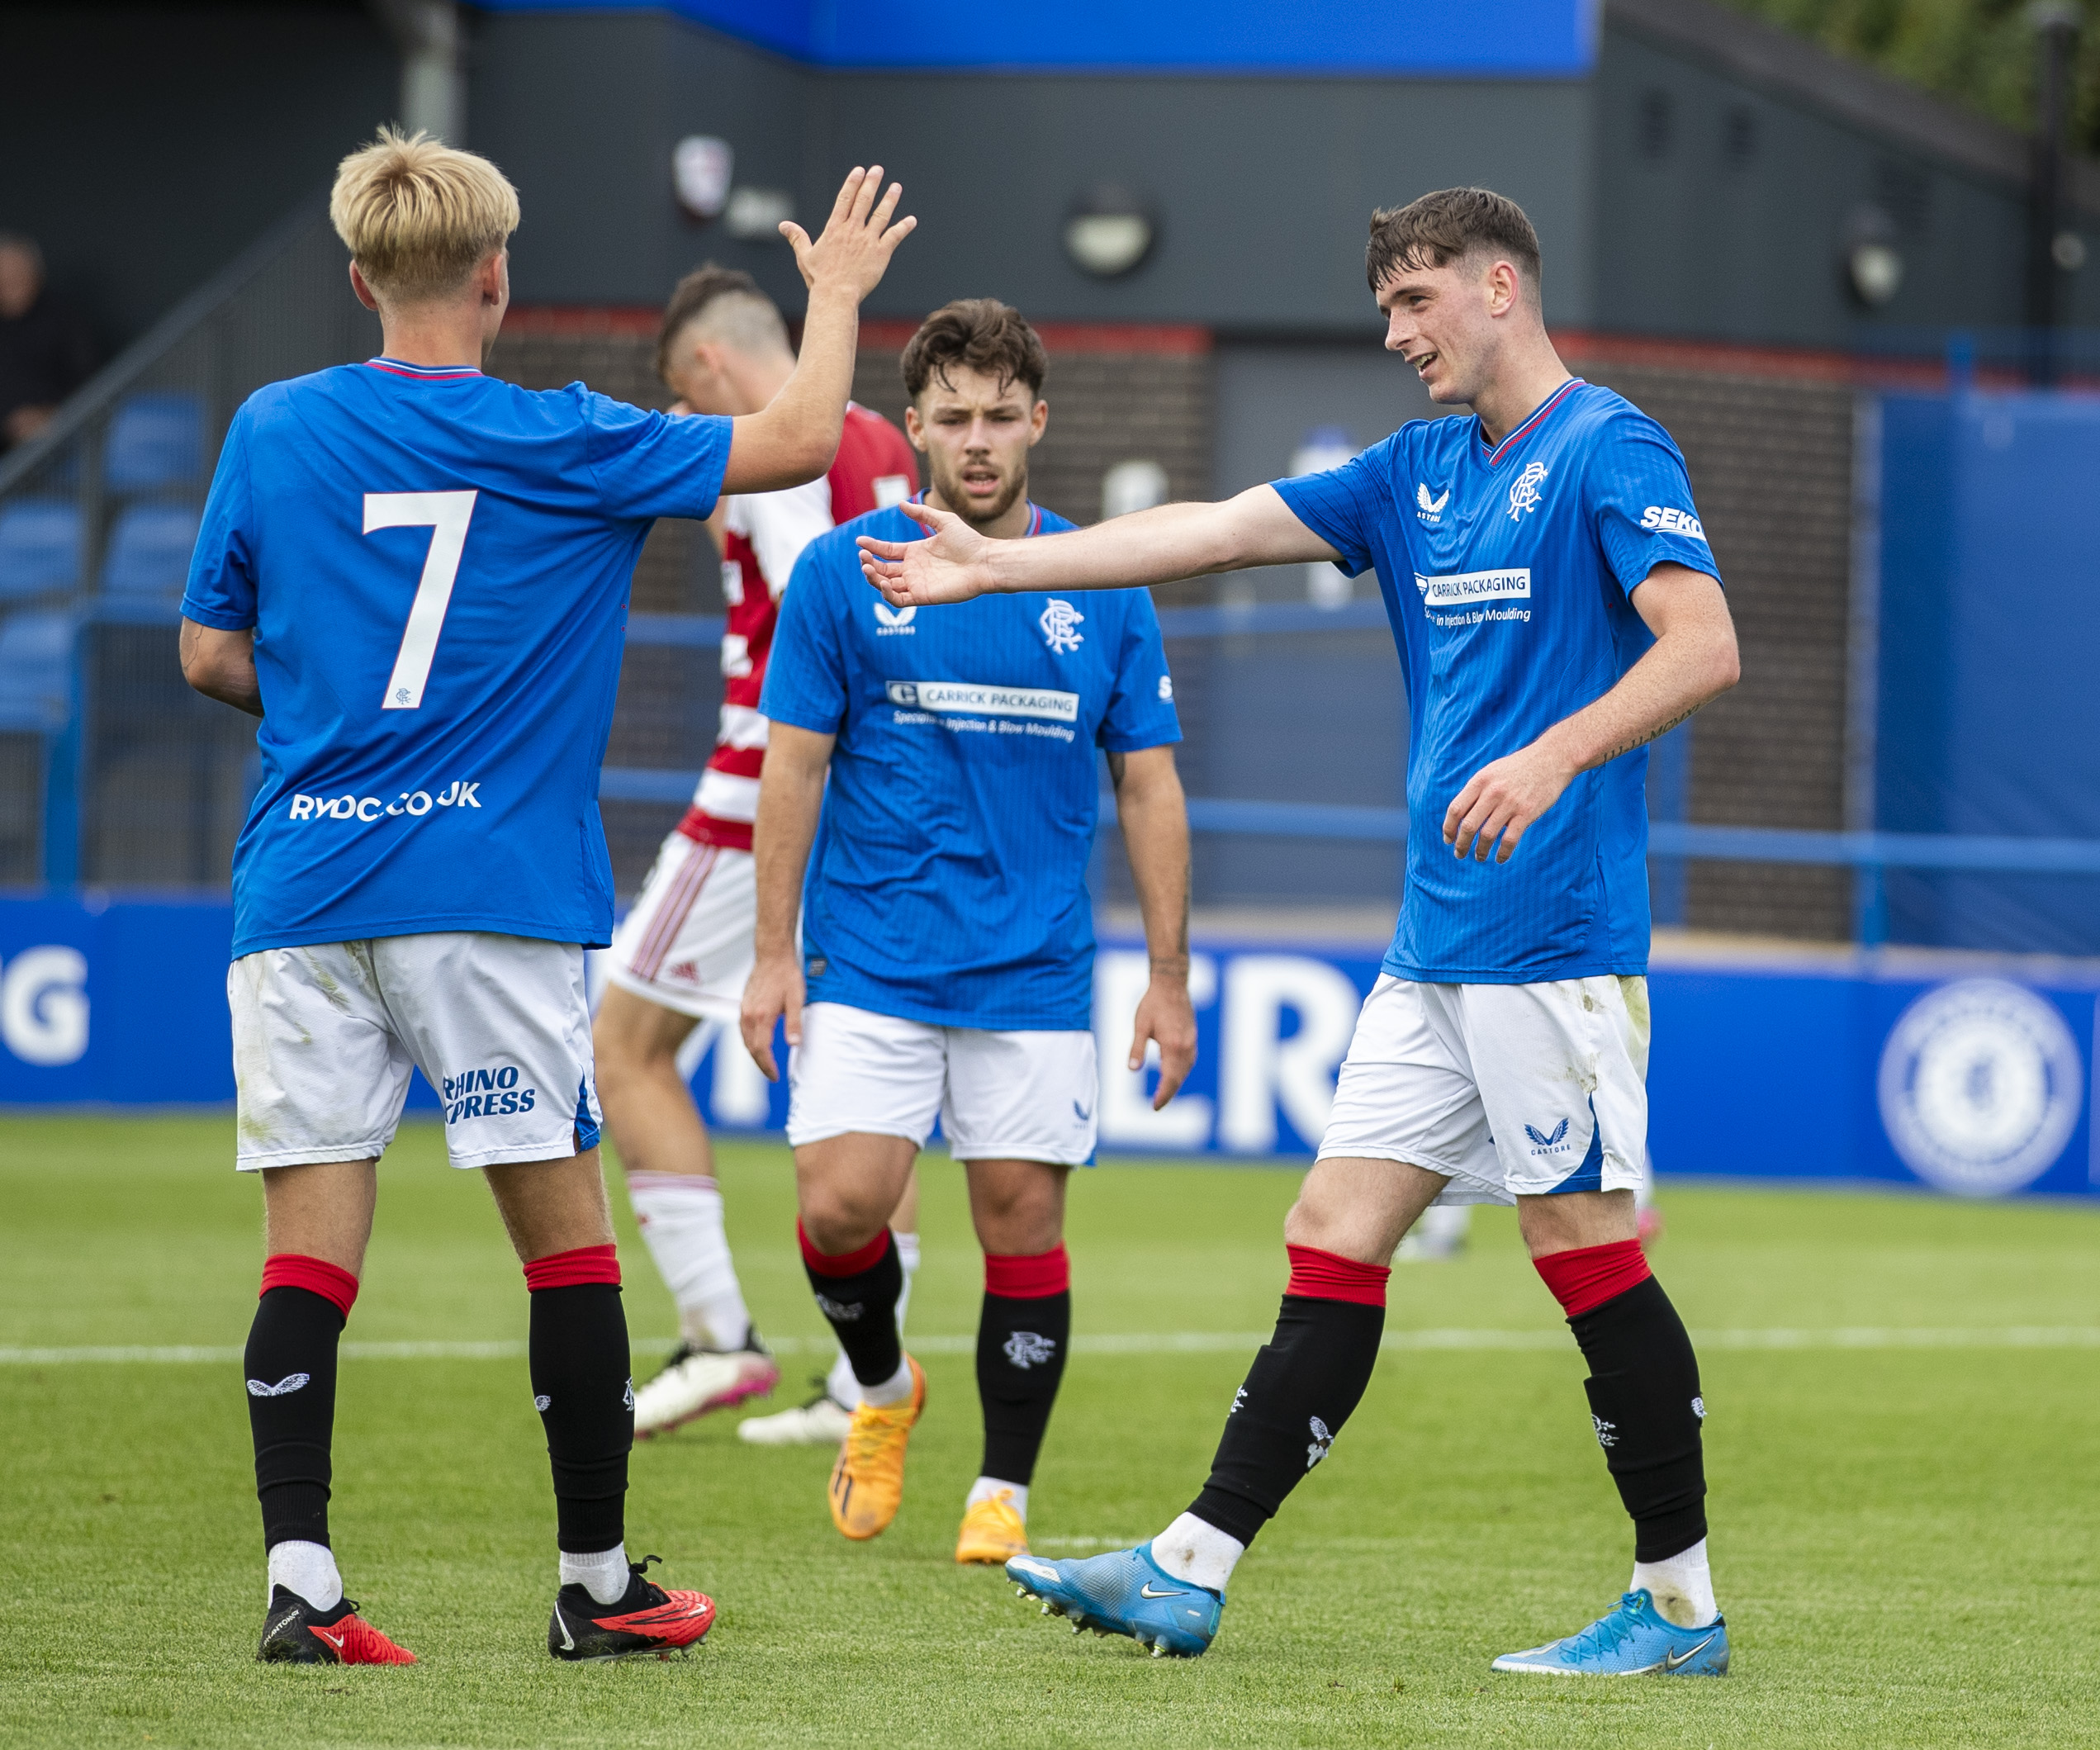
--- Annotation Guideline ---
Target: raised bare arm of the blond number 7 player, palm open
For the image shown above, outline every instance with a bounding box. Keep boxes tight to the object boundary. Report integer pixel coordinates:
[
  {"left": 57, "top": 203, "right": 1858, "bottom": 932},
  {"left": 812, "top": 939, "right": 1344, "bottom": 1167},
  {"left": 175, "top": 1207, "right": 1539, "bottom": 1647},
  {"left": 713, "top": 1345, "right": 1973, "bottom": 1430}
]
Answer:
[{"left": 723, "top": 164, "right": 917, "bottom": 491}]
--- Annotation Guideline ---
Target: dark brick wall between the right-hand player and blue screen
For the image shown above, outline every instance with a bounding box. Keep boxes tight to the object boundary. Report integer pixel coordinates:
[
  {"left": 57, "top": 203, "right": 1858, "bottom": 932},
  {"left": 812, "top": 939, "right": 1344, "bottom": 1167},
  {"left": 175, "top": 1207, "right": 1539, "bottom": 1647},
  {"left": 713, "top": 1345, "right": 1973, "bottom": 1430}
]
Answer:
[{"left": 1565, "top": 340, "right": 1852, "bottom": 939}]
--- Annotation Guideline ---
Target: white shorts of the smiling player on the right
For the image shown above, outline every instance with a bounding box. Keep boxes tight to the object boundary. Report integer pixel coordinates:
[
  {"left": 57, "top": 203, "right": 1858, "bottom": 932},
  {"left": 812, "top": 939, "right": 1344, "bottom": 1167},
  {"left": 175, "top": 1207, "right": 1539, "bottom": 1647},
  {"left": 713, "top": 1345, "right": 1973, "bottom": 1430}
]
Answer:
[{"left": 1319, "top": 973, "right": 1648, "bottom": 1204}]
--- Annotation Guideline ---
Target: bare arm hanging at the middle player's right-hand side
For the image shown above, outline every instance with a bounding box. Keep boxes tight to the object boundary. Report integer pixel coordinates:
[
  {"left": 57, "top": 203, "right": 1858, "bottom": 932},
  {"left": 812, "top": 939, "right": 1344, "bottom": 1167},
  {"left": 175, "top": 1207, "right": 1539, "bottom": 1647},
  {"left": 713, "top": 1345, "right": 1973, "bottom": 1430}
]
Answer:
[{"left": 1109, "top": 748, "right": 1195, "bottom": 1112}]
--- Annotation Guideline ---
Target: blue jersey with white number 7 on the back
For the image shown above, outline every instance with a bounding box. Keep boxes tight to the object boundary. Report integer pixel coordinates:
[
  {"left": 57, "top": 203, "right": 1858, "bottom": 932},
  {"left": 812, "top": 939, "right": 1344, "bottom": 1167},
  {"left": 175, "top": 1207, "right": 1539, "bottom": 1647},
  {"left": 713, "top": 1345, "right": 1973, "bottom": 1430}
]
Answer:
[{"left": 183, "top": 359, "right": 731, "bottom": 956}]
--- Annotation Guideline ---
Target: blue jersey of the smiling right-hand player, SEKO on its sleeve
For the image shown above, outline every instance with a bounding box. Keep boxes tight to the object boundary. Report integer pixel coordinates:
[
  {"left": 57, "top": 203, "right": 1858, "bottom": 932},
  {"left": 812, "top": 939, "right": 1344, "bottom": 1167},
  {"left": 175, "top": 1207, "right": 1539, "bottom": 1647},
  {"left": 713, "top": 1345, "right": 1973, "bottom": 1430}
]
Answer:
[{"left": 1277, "top": 378, "right": 1720, "bottom": 984}]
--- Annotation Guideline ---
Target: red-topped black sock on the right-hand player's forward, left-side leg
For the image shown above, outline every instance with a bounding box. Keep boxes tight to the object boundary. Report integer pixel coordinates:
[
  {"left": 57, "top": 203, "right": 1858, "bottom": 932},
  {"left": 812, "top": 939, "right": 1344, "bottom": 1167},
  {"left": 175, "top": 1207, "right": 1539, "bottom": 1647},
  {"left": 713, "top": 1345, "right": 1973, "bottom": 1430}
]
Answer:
[{"left": 1188, "top": 1245, "right": 1390, "bottom": 1544}]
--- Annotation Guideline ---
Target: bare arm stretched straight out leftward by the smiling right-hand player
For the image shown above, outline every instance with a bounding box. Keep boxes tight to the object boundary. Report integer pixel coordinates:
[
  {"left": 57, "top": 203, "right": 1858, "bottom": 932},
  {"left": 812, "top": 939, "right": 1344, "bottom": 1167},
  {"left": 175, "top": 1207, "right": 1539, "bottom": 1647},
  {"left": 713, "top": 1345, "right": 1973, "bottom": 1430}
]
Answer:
[{"left": 859, "top": 486, "right": 1335, "bottom": 607}]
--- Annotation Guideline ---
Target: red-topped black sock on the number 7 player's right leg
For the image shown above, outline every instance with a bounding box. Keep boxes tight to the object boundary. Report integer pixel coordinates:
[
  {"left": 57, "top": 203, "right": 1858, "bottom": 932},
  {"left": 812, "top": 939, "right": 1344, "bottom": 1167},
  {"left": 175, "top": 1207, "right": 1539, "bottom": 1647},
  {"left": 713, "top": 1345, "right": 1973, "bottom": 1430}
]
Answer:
[{"left": 525, "top": 1245, "right": 634, "bottom": 1554}]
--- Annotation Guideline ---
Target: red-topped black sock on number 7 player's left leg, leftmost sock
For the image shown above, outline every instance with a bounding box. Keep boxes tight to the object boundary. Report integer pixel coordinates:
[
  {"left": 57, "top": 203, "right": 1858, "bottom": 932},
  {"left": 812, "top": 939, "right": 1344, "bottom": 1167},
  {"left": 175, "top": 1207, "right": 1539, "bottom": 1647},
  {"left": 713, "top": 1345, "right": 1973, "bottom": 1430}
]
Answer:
[{"left": 241, "top": 1254, "right": 357, "bottom": 1550}]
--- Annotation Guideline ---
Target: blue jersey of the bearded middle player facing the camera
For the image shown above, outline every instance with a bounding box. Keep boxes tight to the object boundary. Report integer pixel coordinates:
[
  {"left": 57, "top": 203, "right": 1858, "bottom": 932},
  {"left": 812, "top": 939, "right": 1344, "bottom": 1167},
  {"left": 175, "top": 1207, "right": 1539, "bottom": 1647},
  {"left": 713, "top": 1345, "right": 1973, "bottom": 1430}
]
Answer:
[{"left": 758, "top": 497, "right": 1180, "bottom": 1029}]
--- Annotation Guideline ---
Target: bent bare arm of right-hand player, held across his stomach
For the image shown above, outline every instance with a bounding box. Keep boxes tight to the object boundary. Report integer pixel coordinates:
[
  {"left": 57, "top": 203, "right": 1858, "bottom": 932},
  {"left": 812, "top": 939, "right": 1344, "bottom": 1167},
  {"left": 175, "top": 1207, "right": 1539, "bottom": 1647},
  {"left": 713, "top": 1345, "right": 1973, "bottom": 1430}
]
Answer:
[{"left": 1445, "top": 565, "right": 1743, "bottom": 864}]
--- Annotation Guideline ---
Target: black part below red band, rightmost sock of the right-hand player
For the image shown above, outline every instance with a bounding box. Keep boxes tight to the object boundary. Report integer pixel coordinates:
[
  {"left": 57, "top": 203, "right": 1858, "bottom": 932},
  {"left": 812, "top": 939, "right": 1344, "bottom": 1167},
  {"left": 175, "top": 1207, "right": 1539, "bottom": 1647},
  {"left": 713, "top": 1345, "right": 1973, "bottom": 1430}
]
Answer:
[{"left": 1569, "top": 1275, "right": 1707, "bottom": 1561}]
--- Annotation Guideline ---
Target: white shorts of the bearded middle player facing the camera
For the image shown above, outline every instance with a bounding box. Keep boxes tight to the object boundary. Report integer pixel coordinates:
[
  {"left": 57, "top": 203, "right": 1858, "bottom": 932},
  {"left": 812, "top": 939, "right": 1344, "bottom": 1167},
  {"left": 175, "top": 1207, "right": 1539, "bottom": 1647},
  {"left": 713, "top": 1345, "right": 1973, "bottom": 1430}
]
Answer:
[{"left": 788, "top": 1002, "right": 1101, "bottom": 1166}]
